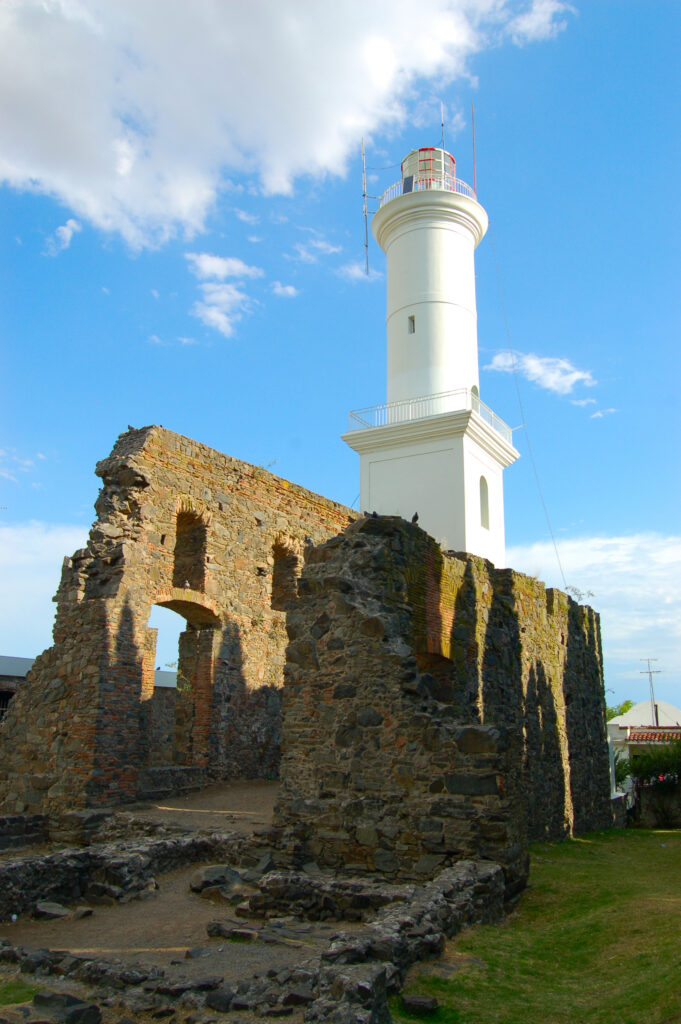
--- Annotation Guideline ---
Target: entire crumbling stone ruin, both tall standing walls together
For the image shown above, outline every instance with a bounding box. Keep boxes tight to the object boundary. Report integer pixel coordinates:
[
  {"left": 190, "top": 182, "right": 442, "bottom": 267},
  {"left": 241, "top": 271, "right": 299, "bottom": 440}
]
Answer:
[{"left": 0, "top": 427, "right": 612, "bottom": 892}]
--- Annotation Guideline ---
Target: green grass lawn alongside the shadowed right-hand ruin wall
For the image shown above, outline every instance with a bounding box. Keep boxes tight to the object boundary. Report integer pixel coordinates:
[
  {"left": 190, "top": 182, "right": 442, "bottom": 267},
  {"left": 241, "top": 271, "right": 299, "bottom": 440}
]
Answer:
[{"left": 390, "top": 829, "right": 681, "bottom": 1024}]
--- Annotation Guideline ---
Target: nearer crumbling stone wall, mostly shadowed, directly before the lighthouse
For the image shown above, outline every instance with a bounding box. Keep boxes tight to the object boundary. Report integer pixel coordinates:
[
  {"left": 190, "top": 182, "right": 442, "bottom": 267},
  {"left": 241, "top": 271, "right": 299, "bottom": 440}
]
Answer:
[{"left": 276, "top": 516, "right": 611, "bottom": 891}]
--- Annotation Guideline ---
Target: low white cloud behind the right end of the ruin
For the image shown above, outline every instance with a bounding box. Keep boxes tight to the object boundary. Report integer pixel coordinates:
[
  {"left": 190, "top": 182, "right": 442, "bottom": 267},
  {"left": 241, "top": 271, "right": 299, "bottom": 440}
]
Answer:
[{"left": 506, "top": 534, "right": 681, "bottom": 705}]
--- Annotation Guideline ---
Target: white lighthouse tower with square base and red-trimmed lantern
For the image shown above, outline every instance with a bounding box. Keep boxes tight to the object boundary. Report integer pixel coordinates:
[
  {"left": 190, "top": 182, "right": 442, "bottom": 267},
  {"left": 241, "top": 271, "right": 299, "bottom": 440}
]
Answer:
[{"left": 343, "top": 148, "right": 518, "bottom": 566}]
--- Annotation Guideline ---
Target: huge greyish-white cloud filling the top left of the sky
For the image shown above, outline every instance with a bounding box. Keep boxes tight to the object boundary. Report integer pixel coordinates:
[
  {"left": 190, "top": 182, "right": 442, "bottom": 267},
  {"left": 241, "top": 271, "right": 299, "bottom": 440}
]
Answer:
[{"left": 0, "top": 0, "right": 568, "bottom": 246}]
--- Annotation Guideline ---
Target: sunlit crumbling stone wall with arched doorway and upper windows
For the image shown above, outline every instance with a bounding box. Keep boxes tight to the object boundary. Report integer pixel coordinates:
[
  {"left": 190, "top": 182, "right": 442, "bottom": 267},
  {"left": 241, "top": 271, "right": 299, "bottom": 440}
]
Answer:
[{"left": 0, "top": 427, "right": 349, "bottom": 813}]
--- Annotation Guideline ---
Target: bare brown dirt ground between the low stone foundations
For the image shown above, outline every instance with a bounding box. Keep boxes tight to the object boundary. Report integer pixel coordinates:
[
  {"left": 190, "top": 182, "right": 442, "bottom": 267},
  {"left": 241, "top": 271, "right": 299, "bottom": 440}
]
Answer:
[{"left": 0, "top": 781, "right": 345, "bottom": 1020}]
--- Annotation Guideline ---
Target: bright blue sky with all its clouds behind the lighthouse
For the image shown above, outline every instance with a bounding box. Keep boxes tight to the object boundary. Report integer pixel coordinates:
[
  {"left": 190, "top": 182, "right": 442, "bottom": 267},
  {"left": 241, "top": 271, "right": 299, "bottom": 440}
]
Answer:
[{"left": 0, "top": 0, "right": 681, "bottom": 706}]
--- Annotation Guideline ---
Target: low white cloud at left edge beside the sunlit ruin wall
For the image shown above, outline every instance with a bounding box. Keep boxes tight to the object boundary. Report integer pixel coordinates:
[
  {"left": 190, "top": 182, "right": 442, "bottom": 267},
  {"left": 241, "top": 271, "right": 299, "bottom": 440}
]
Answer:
[{"left": 0, "top": 522, "right": 88, "bottom": 657}]
